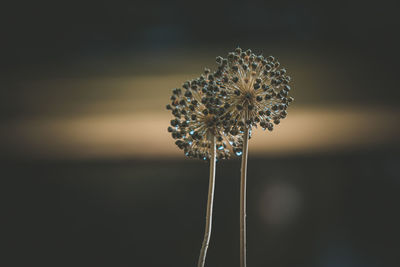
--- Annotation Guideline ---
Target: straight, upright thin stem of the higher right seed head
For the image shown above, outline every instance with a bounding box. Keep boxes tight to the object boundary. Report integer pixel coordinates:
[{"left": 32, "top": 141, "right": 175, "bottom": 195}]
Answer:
[{"left": 240, "top": 127, "right": 249, "bottom": 267}]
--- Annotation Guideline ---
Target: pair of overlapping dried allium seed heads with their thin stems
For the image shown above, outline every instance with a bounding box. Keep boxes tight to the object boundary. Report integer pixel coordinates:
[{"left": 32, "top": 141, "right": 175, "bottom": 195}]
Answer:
[{"left": 167, "top": 48, "right": 293, "bottom": 267}]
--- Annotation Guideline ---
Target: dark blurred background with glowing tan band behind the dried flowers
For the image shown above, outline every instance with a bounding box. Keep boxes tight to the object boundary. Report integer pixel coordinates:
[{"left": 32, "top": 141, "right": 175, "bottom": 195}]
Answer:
[{"left": 0, "top": 0, "right": 400, "bottom": 267}]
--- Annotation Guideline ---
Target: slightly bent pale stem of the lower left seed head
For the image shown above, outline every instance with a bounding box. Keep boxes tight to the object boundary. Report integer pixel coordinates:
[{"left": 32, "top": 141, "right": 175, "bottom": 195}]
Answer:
[{"left": 197, "top": 136, "right": 216, "bottom": 267}]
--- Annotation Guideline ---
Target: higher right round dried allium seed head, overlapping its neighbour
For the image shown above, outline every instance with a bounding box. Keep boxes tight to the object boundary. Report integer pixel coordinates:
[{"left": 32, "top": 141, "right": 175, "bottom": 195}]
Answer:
[{"left": 215, "top": 48, "right": 294, "bottom": 135}]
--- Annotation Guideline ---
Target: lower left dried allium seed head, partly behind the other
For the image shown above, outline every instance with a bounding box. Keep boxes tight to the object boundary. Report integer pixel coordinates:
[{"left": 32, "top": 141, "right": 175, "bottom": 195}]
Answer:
[{"left": 167, "top": 73, "right": 242, "bottom": 159}]
